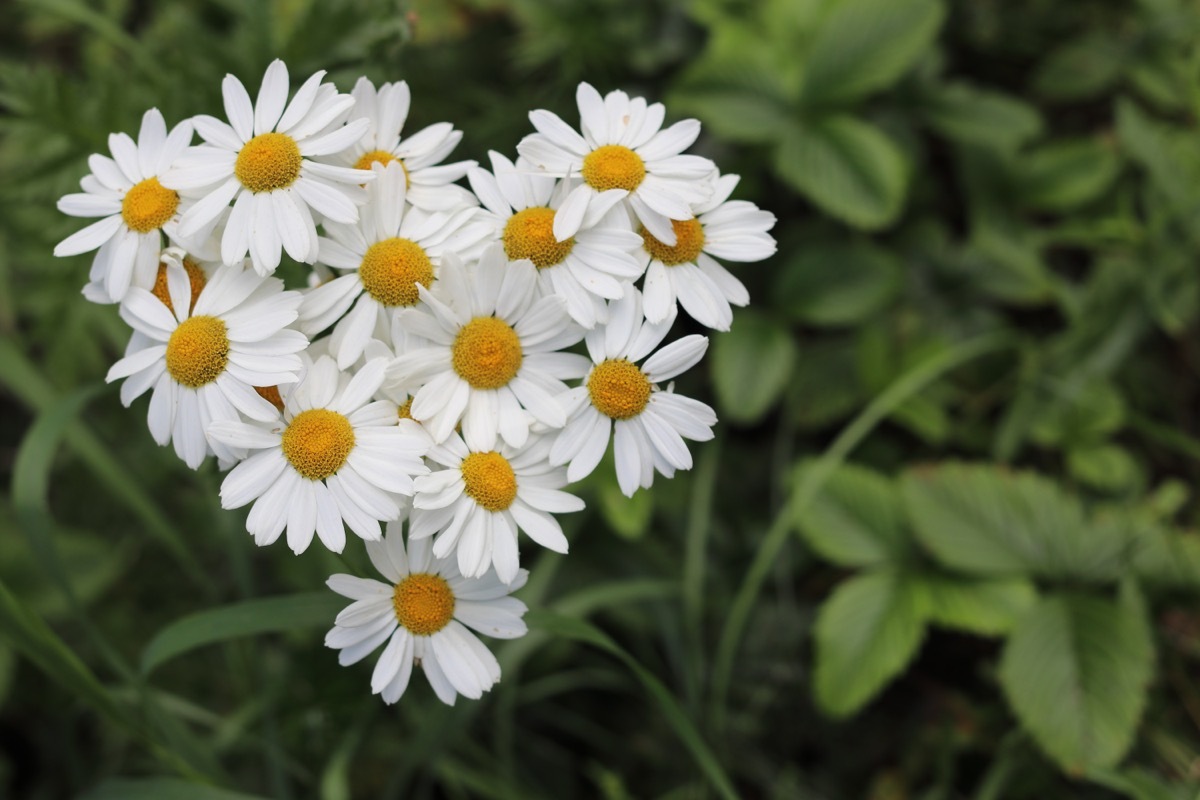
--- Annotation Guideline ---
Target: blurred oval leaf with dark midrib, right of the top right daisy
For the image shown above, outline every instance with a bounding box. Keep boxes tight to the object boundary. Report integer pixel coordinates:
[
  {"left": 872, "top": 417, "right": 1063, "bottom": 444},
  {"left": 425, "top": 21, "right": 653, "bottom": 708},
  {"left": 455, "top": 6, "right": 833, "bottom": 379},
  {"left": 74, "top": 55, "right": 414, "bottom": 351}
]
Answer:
[{"left": 775, "top": 115, "right": 910, "bottom": 230}]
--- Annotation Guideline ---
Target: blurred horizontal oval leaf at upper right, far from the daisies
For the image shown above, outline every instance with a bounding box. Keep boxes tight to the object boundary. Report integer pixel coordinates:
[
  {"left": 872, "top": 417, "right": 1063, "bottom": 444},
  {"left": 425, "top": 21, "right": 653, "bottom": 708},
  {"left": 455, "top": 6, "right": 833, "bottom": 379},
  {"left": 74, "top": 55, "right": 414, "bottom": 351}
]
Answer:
[{"left": 920, "top": 83, "right": 1042, "bottom": 150}]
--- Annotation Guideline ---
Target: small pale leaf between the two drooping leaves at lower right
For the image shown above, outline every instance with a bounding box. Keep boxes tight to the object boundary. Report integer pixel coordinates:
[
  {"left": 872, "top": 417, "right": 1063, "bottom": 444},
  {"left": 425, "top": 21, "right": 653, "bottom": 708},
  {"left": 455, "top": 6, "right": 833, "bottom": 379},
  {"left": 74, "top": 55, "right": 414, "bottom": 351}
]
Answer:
[{"left": 920, "top": 575, "right": 1038, "bottom": 636}]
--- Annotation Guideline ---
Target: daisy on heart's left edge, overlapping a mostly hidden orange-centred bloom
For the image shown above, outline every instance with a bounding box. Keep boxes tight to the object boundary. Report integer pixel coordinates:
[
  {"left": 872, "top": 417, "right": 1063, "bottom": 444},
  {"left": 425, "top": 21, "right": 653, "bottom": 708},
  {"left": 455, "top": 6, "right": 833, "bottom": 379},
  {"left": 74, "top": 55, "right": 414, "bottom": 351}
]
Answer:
[{"left": 106, "top": 253, "right": 308, "bottom": 469}]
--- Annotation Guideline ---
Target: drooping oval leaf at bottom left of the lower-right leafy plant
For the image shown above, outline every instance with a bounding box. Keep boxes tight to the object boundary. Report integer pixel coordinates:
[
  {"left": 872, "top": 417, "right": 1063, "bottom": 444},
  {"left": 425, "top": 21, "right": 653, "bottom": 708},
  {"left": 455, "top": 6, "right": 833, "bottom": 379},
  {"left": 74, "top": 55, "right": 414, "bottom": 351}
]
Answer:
[{"left": 814, "top": 571, "right": 925, "bottom": 717}]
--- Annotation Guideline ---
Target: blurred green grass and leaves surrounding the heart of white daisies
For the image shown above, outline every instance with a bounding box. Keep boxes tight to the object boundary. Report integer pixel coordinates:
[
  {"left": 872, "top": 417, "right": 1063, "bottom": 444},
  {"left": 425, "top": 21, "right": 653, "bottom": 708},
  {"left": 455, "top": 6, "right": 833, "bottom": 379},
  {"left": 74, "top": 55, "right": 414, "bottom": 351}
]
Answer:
[{"left": 7, "top": 0, "right": 1200, "bottom": 800}]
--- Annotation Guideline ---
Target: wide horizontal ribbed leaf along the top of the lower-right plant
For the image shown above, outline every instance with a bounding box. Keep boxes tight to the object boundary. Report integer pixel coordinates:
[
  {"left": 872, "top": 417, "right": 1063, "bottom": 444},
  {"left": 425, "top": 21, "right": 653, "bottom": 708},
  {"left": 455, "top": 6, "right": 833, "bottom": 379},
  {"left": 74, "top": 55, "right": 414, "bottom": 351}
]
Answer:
[{"left": 900, "top": 463, "right": 1129, "bottom": 581}]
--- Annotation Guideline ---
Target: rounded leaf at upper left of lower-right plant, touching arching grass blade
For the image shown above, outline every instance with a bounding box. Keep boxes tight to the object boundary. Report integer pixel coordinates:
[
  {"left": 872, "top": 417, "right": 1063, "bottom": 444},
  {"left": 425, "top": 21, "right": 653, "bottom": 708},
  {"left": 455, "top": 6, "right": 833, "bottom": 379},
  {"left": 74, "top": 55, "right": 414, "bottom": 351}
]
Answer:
[{"left": 796, "top": 464, "right": 912, "bottom": 566}]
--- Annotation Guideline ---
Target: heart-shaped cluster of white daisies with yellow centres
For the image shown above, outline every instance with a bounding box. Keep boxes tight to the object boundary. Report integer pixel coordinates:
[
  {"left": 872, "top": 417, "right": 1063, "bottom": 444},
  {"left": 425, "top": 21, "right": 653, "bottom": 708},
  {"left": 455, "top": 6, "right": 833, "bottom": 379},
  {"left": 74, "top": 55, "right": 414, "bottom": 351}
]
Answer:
[{"left": 54, "top": 61, "right": 775, "bottom": 703}]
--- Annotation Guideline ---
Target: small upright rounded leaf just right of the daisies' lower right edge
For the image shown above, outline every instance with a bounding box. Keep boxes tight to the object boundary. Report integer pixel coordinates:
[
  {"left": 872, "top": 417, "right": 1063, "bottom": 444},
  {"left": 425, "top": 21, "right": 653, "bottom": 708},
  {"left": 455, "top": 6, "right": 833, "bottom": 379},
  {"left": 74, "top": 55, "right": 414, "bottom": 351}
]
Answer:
[{"left": 712, "top": 311, "right": 796, "bottom": 425}]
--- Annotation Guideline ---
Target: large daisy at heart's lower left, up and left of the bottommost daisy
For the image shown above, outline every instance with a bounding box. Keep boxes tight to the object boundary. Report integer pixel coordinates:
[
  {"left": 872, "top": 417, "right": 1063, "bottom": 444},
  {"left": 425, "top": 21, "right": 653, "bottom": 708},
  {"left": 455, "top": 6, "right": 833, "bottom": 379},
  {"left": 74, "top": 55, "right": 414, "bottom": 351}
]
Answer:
[{"left": 208, "top": 356, "right": 428, "bottom": 553}]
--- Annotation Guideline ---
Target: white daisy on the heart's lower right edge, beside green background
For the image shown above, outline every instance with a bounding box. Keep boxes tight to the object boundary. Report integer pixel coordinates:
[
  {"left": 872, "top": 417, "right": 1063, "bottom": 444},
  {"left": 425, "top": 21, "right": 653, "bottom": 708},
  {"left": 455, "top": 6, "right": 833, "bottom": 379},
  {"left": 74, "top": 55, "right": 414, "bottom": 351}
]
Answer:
[{"left": 550, "top": 287, "right": 716, "bottom": 497}]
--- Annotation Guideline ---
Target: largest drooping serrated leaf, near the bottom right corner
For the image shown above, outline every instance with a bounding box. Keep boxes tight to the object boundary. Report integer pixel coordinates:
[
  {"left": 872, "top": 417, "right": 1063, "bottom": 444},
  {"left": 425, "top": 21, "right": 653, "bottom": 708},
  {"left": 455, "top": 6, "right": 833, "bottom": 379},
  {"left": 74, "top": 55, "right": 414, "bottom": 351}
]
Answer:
[{"left": 1000, "top": 585, "right": 1154, "bottom": 774}]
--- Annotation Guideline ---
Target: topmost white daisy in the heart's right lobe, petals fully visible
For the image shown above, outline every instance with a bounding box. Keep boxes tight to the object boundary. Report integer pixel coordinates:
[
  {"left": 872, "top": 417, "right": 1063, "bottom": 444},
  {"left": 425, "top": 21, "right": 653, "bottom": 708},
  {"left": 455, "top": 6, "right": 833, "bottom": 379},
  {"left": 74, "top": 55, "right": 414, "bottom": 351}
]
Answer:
[{"left": 517, "top": 83, "right": 716, "bottom": 245}]
